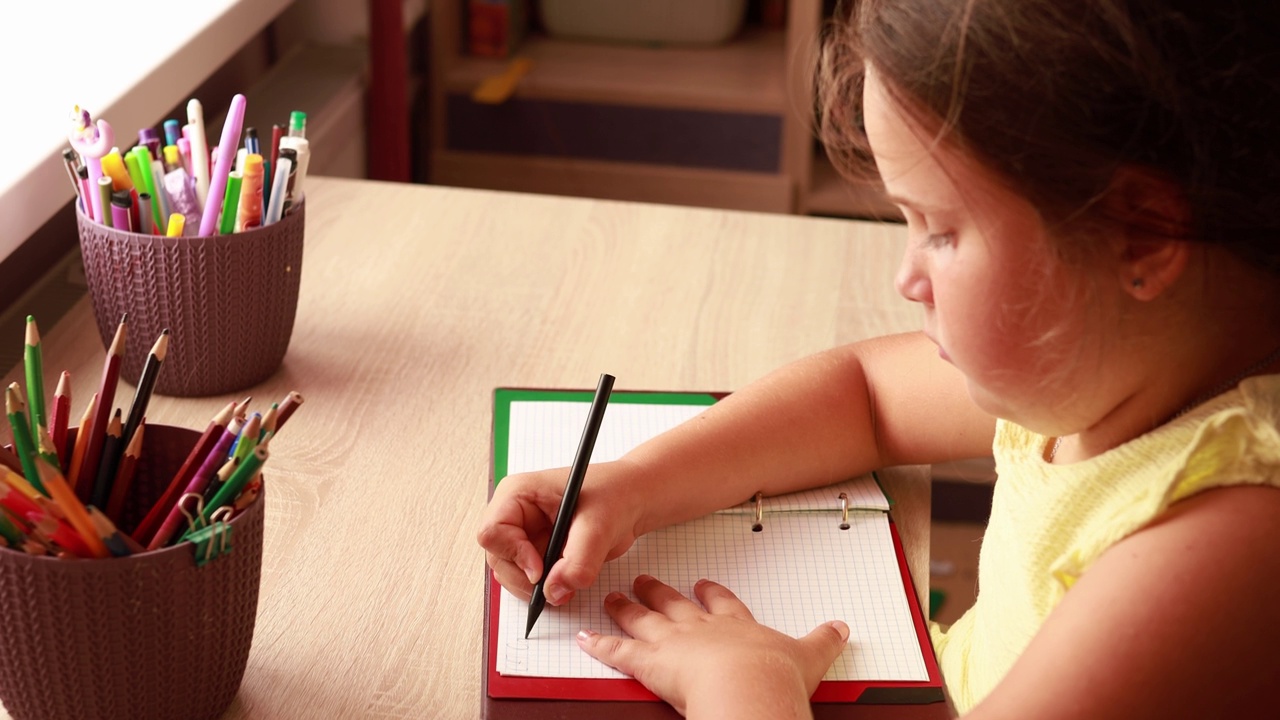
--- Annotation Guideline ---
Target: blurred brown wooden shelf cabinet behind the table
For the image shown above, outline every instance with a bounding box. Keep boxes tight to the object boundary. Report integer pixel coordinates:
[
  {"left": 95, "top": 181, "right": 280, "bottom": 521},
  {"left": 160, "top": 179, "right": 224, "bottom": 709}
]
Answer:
[{"left": 429, "top": 0, "right": 893, "bottom": 217}]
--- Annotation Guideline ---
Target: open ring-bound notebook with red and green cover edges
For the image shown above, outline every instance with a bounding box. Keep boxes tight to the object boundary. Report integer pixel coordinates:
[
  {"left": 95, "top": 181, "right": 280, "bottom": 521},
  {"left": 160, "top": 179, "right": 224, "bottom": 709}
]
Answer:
[{"left": 484, "top": 388, "right": 947, "bottom": 717}]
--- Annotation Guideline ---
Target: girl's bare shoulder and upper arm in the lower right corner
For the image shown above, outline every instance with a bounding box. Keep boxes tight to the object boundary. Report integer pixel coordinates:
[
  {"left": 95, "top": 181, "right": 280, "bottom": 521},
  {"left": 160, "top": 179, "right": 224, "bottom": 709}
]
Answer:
[{"left": 973, "top": 484, "right": 1280, "bottom": 719}]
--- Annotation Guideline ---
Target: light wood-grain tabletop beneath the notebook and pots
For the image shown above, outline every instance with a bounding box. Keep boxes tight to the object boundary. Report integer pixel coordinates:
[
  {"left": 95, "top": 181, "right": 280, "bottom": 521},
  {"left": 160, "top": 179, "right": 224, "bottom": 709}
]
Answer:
[{"left": 4, "top": 178, "right": 929, "bottom": 720}]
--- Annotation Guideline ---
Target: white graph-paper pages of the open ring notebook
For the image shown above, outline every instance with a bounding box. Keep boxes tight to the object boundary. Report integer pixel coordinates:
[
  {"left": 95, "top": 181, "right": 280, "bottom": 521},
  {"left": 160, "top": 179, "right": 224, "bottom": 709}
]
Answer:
[{"left": 497, "top": 402, "right": 928, "bottom": 680}]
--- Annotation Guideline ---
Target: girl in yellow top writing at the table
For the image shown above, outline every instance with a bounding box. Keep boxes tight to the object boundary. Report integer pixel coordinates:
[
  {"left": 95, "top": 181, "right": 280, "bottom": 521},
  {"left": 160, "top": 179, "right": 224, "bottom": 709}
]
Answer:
[{"left": 479, "top": 0, "right": 1280, "bottom": 719}]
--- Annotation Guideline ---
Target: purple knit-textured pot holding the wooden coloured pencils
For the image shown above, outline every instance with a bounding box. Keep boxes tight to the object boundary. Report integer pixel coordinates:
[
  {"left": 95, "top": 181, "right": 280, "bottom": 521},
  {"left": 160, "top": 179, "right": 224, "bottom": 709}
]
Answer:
[{"left": 0, "top": 424, "right": 266, "bottom": 720}]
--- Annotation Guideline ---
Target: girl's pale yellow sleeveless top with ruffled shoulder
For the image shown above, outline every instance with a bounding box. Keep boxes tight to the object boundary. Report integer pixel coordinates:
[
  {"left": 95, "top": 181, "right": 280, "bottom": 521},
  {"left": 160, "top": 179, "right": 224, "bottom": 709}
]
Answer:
[{"left": 933, "top": 375, "right": 1280, "bottom": 714}]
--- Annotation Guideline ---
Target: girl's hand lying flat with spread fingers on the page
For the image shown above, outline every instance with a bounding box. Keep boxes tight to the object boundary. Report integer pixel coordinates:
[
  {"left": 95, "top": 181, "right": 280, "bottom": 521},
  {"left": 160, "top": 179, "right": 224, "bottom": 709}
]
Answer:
[{"left": 577, "top": 575, "right": 849, "bottom": 719}]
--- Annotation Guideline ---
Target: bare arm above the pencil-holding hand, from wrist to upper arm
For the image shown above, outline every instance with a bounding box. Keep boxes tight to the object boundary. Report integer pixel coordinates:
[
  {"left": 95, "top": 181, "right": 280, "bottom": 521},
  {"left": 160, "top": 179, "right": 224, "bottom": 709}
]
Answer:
[{"left": 623, "top": 333, "right": 995, "bottom": 533}]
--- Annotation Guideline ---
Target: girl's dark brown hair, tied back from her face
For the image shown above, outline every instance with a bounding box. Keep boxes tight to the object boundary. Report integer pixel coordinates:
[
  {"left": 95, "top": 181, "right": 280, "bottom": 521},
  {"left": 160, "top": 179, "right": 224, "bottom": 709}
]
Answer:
[{"left": 818, "top": 0, "right": 1280, "bottom": 274}]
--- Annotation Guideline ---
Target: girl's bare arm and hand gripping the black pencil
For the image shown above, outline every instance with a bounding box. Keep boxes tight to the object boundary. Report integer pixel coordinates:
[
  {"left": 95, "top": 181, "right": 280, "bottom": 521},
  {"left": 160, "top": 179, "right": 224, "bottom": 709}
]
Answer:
[{"left": 477, "top": 333, "right": 995, "bottom": 605}]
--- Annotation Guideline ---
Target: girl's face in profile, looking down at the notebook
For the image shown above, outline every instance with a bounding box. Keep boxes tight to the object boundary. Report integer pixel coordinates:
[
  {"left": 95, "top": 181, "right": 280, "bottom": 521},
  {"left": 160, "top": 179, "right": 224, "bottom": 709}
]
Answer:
[{"left": 864, "top": 69, "right": 1087, "bottom": 433}]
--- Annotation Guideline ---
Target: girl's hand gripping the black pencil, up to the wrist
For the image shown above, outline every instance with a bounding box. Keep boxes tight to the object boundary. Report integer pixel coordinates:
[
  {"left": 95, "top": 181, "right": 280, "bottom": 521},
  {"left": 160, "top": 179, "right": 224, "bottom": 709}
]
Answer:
[{"left": 476, "top": 460, "right": 643, "bottom": 605}]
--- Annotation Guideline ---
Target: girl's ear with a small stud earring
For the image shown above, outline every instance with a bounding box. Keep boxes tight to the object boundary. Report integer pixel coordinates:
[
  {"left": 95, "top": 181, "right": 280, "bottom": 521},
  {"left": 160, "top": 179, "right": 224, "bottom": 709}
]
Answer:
[{"left": 1103, "top": 168, "right": 1192, "bottom": 301}]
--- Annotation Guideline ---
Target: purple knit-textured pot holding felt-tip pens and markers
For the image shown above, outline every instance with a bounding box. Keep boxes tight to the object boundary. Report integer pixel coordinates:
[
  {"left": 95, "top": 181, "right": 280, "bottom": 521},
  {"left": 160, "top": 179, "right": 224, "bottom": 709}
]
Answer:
[{"left": 76, "top": 202, "right": 306, "bottom": 397}]
